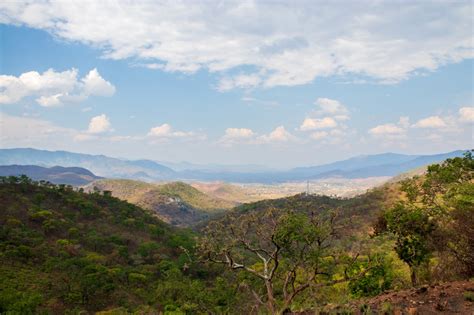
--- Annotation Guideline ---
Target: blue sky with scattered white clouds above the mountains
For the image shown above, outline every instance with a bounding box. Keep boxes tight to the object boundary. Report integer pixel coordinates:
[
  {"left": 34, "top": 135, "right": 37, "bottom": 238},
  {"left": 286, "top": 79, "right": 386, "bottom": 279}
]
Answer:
[{"left": 0, "top": 0, "right": 474, "bottom": 168}]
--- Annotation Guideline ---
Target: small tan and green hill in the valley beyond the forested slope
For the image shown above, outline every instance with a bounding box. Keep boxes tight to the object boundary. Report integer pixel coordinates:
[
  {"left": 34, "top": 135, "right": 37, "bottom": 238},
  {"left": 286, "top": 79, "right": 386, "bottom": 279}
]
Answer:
[{"left": 86, "top": 179, "right": 236, "bottom": 226}]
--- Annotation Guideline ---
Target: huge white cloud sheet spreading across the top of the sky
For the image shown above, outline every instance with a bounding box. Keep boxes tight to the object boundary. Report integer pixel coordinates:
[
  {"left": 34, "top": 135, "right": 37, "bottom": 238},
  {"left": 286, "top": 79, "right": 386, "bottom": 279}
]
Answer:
[{"left": 0, "top": 0, "right": 473, "bottom": 89}]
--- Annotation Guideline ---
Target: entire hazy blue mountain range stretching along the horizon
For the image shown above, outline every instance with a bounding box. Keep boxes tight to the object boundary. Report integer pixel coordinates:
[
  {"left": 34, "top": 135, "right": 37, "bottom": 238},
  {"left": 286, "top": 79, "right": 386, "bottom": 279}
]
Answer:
[{"left": 0, "top": 148, "right": 464, "bottom": 183}]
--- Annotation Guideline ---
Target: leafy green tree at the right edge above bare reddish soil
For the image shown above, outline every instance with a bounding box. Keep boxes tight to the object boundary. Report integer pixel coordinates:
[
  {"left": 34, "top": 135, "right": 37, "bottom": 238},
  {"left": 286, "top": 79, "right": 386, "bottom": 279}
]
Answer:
[{"left": 375, "top": 151, "right": 474, "bottom": 285}]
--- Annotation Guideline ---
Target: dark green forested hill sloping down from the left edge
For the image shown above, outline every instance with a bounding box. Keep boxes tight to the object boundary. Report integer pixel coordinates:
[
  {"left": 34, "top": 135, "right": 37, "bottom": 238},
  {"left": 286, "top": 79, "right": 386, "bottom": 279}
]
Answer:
[{"left": 0, "top": 177, "right": 228, "bottom": 314}]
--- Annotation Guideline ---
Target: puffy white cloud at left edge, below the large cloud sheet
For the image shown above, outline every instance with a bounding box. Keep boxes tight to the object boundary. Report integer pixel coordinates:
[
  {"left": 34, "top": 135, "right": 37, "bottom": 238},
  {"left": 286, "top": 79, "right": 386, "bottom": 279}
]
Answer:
[{"left": 0, "top": 68, "right": 115, "bottom": 107}]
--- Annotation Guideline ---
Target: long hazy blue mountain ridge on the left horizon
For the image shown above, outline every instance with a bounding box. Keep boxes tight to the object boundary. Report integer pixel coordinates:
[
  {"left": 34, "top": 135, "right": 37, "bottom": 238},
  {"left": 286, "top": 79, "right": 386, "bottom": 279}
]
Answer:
[{"left": 0, "top": 149, "right": 176, "bottom": 181}]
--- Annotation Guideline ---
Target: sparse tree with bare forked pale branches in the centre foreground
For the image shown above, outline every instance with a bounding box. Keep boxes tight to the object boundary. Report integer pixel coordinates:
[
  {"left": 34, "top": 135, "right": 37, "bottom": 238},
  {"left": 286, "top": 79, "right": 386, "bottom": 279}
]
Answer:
[{"left": 199, "top": 209, "right": 366, "bottom": 314}]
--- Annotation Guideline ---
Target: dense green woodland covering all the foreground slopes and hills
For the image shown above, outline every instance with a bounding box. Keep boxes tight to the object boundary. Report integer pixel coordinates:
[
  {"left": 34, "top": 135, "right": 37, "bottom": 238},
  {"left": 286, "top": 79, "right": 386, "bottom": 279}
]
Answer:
[{"left": 0, "top": 152, "right": 474, "bottom": 314}]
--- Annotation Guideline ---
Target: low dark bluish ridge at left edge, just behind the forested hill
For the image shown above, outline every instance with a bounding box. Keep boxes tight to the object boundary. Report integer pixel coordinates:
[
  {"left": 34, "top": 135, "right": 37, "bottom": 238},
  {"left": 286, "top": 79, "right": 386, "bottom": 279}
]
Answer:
[{"left": 0, "top": 165, "right": 101, "bottom": 186}]
